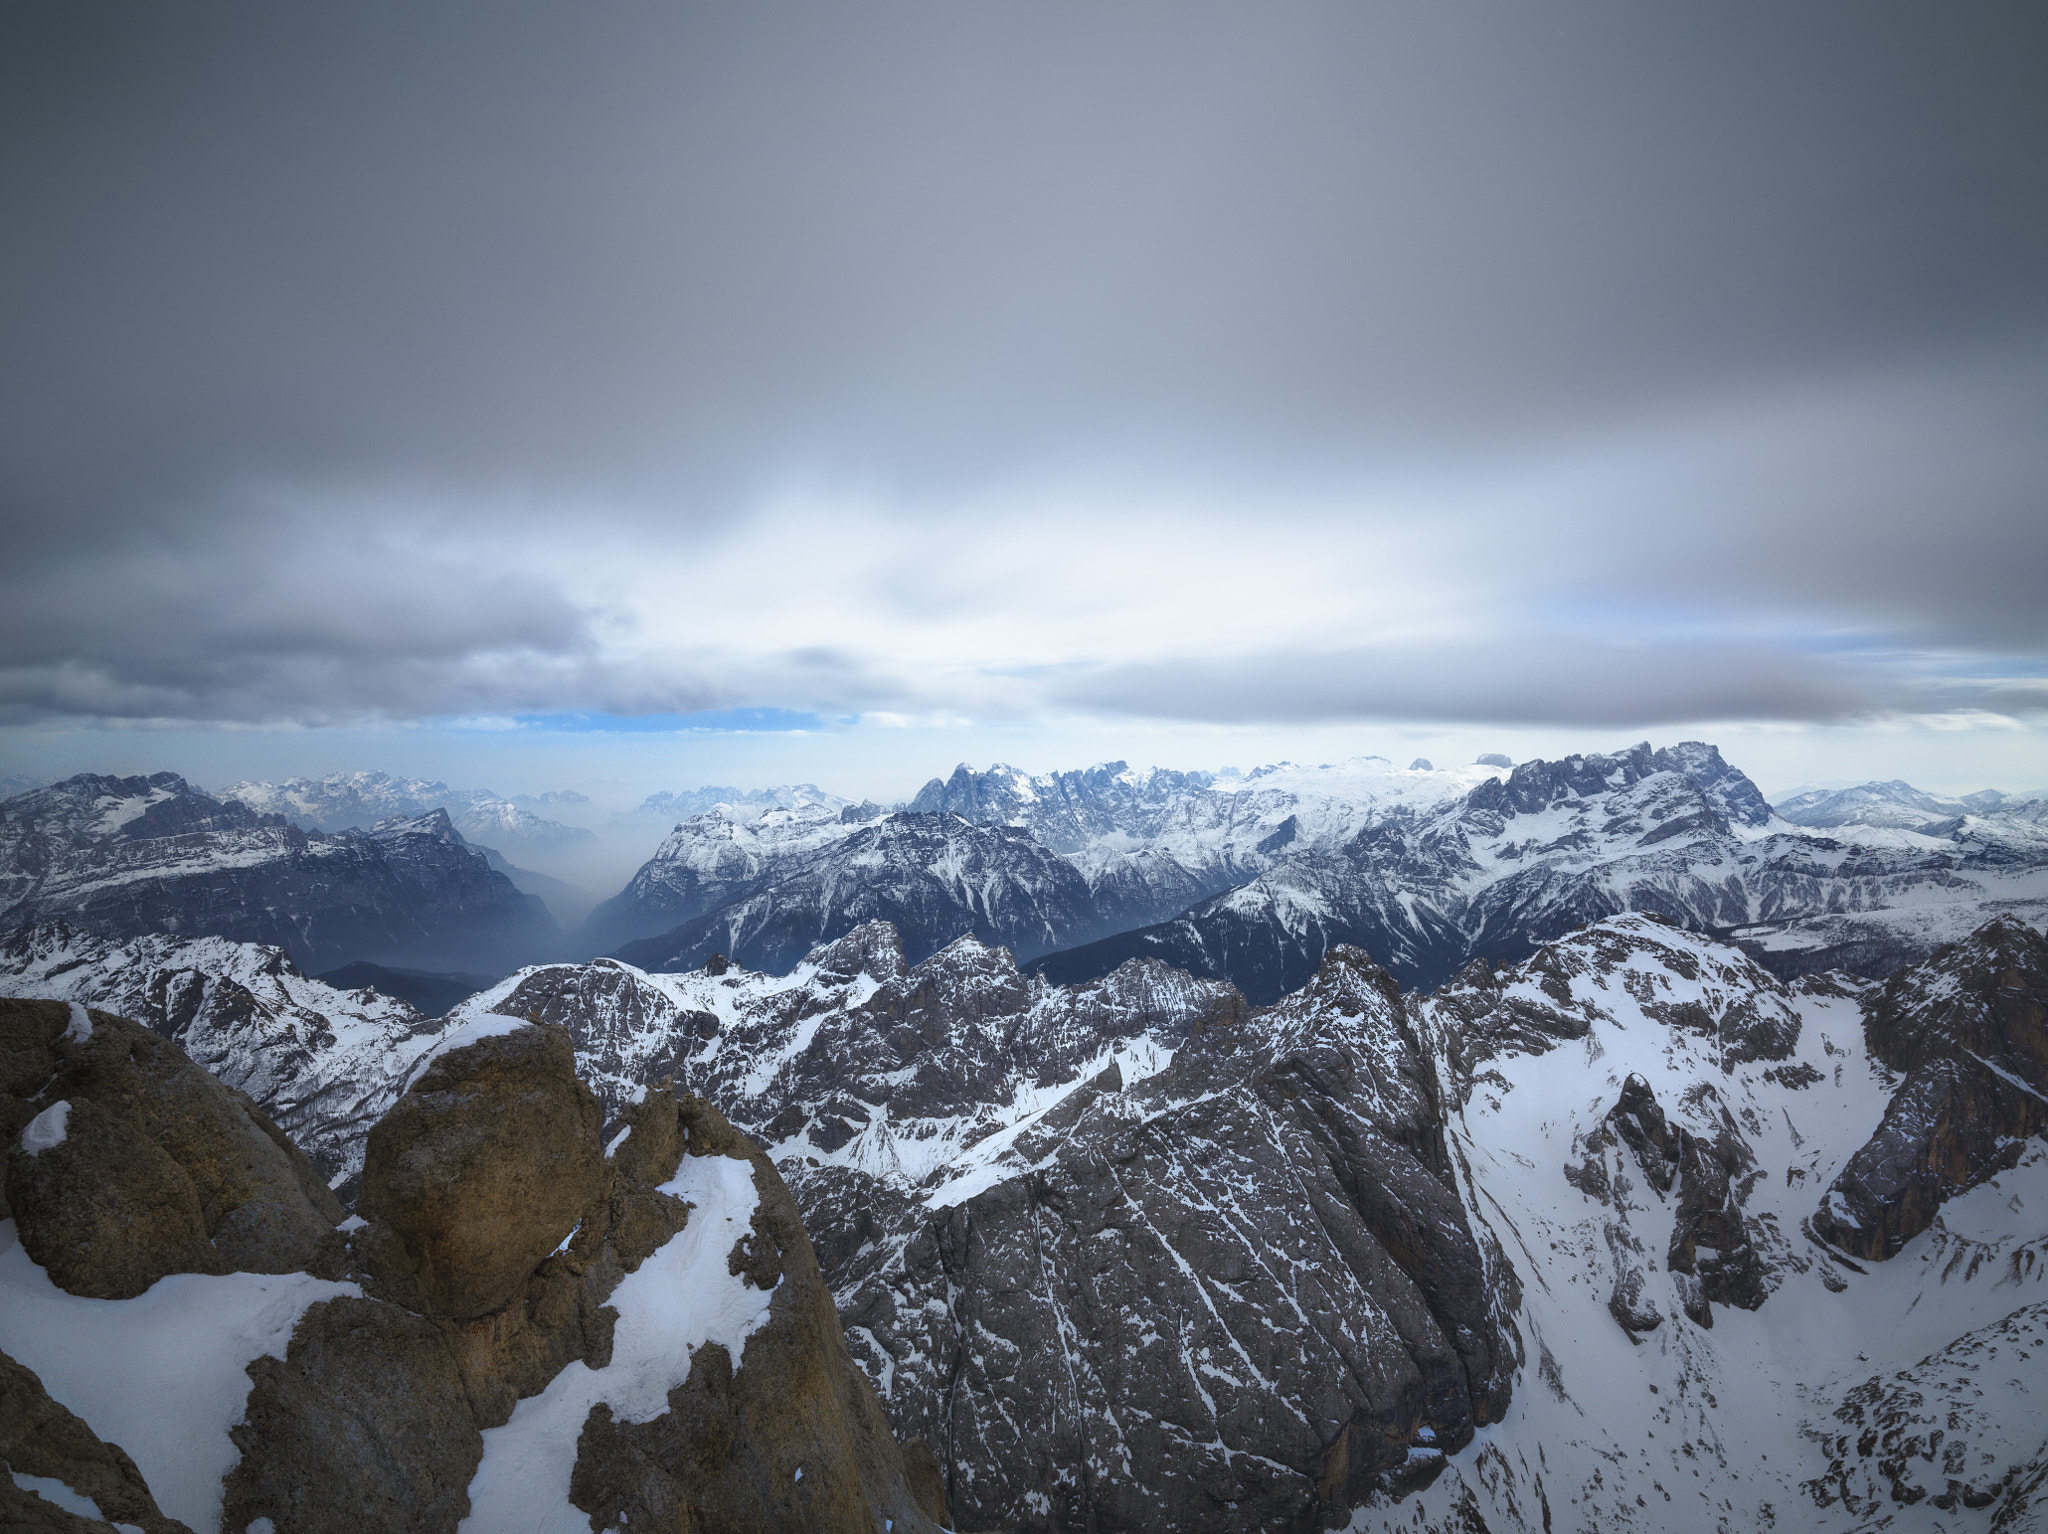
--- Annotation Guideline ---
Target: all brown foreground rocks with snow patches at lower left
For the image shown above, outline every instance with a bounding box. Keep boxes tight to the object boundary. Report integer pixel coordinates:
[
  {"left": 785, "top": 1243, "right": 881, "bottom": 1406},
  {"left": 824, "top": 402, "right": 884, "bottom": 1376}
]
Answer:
[{"left": 0, "top": 1002, "right": 932, "bottom": 1534}]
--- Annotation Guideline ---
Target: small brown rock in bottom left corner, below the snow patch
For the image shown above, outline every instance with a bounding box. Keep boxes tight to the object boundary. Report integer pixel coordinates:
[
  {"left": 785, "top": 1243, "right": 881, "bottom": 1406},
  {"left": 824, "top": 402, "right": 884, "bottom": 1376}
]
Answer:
[{"left": 0, "top": 1354, "right": 193, "bottom": 1534}]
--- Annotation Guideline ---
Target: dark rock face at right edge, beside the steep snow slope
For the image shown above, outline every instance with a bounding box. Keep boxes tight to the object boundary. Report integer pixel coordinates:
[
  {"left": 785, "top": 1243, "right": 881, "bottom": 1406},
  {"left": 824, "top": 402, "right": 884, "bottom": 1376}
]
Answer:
[{"left": 1812, "top": 920, "right": 2048, "bottom": 1260}]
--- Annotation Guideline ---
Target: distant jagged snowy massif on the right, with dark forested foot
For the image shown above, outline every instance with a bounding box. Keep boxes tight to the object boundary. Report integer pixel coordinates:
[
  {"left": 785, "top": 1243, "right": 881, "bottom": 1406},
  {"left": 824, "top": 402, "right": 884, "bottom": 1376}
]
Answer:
[{"left": 1038, "top": 741, "right": 2048, "bottom": 1002}]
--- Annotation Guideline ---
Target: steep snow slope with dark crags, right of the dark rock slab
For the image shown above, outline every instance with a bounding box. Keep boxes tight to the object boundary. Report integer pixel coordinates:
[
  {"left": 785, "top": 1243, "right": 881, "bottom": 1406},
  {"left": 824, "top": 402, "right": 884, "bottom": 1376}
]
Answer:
[{"left": 1352, "top": 918, "right": 2048, "bottom": 1534}]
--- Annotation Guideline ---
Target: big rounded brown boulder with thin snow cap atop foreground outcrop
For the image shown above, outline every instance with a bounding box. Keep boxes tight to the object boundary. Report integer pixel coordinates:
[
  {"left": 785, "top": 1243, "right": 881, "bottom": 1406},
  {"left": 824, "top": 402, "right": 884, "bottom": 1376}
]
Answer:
[{"left": 356, "top": 1026, "right": 604, "bottom": 1319}]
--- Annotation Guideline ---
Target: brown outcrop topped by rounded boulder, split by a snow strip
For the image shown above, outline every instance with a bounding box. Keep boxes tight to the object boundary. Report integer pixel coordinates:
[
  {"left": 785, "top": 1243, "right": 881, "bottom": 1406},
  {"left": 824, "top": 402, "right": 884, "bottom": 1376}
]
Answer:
[{"left": 227, "top": 1024, "right": 946, "bottom": 1534}]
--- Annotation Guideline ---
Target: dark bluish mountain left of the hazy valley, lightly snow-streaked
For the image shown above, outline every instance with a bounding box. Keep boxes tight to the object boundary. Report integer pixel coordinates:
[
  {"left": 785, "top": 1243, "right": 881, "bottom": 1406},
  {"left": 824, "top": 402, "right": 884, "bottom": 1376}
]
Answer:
[{"left": 0, "top": 772, "right": 555, "bottom": 971}]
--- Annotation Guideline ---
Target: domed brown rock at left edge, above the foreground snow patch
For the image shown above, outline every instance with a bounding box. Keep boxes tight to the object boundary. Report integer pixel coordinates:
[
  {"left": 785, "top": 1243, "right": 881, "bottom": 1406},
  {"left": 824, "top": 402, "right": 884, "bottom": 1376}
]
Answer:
[{"left": 0, "top": 999, "right": 342, "bottom": 1298}]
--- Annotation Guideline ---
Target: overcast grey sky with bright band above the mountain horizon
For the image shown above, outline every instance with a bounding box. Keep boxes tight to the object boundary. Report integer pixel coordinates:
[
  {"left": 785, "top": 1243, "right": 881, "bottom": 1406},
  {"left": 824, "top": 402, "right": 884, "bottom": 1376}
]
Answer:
[{"left": 0, "top": 0, "right": 2048, "bottom": 793}]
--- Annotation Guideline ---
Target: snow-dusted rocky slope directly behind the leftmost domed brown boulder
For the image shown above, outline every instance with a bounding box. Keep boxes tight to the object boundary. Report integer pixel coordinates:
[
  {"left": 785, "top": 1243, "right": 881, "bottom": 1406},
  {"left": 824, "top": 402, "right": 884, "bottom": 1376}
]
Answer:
[{"left": 0, "top": 922, "right": 440, "bottom": 1190}]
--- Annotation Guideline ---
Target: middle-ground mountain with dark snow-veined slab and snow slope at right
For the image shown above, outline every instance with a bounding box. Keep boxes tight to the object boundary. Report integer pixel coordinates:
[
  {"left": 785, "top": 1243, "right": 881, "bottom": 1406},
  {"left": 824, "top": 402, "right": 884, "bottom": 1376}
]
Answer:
[{"left": 16, "top": 892, "right": 2048, "bottom": 1534}]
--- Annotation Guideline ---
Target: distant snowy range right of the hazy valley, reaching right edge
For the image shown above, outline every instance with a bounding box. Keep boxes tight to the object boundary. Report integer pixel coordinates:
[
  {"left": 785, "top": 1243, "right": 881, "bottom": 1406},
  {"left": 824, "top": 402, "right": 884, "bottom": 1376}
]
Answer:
[{"left": 584, "top": 741, "right": 2048, "bottom": 1002}]
